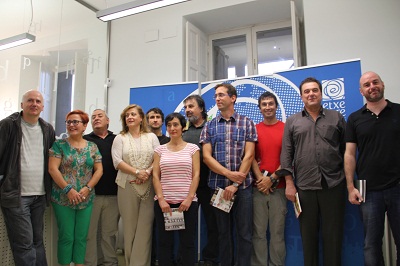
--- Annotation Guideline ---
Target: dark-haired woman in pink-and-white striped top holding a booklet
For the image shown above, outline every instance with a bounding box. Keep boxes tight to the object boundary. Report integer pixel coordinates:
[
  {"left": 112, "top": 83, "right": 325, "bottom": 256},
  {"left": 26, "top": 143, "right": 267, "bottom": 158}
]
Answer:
[{"left": 153, "top": 113, "right": 200, "bottom": 266}]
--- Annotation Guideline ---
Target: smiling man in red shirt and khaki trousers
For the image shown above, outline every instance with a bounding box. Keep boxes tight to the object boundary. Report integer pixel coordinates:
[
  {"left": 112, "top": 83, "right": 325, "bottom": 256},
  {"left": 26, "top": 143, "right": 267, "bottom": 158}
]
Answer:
[{"left": 251, "top": 92, "right": 287, "bottom": 265}]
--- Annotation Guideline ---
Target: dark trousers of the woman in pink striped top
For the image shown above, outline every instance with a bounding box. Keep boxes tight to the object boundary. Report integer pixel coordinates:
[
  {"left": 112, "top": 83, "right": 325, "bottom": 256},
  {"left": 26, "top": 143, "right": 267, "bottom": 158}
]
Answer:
[{"left": 154, "top": 201, "right": 198, "bottom": 266}]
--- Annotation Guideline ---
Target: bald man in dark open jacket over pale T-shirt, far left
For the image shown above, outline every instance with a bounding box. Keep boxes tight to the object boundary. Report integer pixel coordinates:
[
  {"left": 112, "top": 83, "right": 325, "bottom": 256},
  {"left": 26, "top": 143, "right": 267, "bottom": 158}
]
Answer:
[{"left": 0, "top": 90, "right": 55, "bottom": 266}]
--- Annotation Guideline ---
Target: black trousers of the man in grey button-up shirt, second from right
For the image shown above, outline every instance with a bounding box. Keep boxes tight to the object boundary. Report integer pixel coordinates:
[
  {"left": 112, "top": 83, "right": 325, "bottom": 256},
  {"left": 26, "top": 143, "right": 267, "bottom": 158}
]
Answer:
[{"left": 298, "top": 179, "right": 346, "bottom": 266}]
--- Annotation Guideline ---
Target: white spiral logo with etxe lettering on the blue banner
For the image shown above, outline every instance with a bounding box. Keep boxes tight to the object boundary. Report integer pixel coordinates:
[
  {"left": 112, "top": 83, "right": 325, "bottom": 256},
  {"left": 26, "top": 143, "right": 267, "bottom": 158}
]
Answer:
[{"left": 321, "top": 78, "right": 346, "bottom": 117}]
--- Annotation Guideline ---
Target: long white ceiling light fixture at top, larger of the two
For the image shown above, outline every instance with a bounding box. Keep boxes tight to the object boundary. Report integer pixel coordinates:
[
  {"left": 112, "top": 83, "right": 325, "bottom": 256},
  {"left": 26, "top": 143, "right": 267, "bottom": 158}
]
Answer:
[{"left": 96, "top": 0, "right": 189, "bottom": 21}]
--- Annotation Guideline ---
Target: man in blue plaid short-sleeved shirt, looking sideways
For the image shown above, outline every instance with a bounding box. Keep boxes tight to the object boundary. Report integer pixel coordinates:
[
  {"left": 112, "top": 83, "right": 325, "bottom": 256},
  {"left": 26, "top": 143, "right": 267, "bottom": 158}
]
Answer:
[{"left": 200, "top": 83, "right": 257, "bottom": 266}]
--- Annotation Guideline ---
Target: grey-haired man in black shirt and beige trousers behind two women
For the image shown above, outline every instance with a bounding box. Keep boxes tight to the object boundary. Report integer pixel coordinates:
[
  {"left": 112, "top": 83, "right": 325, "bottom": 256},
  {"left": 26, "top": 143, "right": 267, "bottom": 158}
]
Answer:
[{"left": 84, "top": 109, "right": 119, "bottom": 266}]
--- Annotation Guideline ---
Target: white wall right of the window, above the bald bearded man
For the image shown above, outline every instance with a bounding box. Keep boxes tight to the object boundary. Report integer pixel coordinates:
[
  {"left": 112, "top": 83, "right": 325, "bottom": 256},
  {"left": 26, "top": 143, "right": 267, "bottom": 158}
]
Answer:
[{"left": 303, "top": 0, "right": 400, "bottom": 102}]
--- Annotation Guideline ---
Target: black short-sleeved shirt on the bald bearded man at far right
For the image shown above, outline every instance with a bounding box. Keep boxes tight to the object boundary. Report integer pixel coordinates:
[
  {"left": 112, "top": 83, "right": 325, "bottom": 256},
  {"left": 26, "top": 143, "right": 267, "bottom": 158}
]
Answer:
[{"left": 346, "top": 100, "right": 400, "bottom": 191}]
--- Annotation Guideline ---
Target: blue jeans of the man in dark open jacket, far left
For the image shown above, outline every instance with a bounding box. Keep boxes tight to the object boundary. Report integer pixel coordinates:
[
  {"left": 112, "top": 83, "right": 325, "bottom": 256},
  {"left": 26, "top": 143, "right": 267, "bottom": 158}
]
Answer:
[{"left": 1, "top": 195, "right": 47, "bottom": 266}]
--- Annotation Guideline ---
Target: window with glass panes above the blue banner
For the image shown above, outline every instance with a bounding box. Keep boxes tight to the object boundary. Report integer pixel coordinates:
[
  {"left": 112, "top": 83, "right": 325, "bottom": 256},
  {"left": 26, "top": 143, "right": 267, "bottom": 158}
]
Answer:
[{"left": 209, "top": 21, "right": 294, "bottom": 80}]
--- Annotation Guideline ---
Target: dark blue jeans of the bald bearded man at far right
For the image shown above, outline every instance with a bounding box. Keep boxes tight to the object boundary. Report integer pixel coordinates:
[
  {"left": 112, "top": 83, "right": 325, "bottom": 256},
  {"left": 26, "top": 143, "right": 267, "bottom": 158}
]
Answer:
[{"left": 360, "top": 184, "right": 400, "bottom": 266}]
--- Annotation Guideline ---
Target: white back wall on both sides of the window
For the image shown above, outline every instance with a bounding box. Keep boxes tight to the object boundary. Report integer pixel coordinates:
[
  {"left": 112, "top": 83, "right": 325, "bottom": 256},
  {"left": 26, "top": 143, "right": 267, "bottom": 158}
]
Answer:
[{"left": 108, "top": 0, "right": 400, "bottom": 132}]
